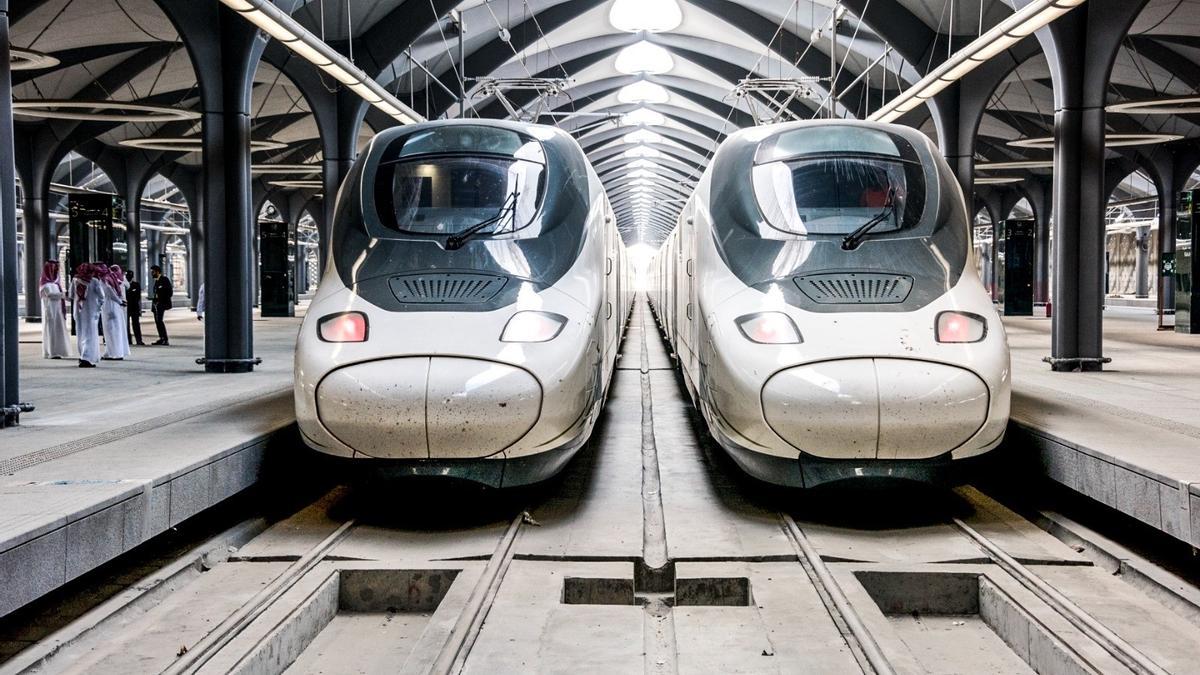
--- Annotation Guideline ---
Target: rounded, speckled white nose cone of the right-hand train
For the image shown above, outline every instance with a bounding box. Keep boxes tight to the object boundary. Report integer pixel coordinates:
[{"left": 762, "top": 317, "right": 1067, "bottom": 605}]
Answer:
[{"left": 762, "top": 358, "right": 989, "bottom": 459}]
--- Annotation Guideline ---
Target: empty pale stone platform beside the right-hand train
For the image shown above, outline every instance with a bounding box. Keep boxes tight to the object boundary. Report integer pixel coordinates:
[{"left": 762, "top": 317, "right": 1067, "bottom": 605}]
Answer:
[{"left": 1004, "top": 306, "right": 1200, "bottom": 546}]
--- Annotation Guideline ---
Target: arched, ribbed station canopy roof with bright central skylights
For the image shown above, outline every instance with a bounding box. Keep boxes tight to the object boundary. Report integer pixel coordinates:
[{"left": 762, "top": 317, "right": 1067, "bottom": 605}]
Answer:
[{"left": 11, "top": 0, "right": 1200, "bottom": 245}]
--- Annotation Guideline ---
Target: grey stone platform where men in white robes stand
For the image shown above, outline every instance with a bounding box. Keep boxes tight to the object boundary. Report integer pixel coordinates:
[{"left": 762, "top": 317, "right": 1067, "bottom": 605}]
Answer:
[{"left": 0, "top": 309, "right": 300, "bottom": 616}]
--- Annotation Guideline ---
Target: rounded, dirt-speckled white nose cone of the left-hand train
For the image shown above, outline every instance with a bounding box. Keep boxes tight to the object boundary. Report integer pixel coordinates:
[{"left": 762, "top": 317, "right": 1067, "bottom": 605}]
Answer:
[{"left": 317, "top": 357, "right": 541, "bottom": 459}]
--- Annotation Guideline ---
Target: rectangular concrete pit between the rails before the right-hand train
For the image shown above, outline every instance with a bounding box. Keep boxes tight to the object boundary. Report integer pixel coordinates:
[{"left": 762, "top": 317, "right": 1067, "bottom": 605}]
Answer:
[{"left": 854, "top": 571, "right": 1090, "bottom": 675}]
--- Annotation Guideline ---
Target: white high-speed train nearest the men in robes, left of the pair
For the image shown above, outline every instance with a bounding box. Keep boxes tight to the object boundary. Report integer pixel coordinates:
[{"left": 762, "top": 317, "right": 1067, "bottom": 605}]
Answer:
[{"left": 295, "top": 120, "right": 631, "bottom": 486}]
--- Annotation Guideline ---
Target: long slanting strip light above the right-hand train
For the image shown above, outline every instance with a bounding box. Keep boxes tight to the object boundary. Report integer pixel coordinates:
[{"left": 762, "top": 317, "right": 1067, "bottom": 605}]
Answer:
[{"left": 866, "top": 0, "right": 1085, "bottom": 121}]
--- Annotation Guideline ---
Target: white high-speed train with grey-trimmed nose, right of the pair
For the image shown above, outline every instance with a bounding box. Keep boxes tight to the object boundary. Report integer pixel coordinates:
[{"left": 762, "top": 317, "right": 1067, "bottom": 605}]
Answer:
[{"left": 650, "top": 121, "right": 1010, "bottom": 486}]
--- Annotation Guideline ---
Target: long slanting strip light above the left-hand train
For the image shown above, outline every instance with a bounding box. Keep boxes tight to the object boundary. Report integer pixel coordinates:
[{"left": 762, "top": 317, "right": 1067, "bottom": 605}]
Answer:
[{"left": 221, "top": 0, "right": 425, "bottom": 124}]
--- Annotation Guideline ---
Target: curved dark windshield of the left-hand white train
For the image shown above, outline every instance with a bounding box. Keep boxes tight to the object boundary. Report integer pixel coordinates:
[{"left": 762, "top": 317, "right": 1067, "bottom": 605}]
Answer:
[{"left": 376, "top": 126, "right": 546, "bottom": 238}]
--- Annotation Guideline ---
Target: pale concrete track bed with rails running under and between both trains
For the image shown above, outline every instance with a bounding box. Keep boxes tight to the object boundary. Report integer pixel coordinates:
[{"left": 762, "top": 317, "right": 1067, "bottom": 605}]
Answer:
[{"left": 7, "top": 300, "right": 1200, "bottom": 674}]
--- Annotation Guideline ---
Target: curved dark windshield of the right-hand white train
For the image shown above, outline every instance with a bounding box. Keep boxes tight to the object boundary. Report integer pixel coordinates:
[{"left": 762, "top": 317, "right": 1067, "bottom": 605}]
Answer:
[{"left": 754, "top": 126, "right": 925, "bottom": 237}]
